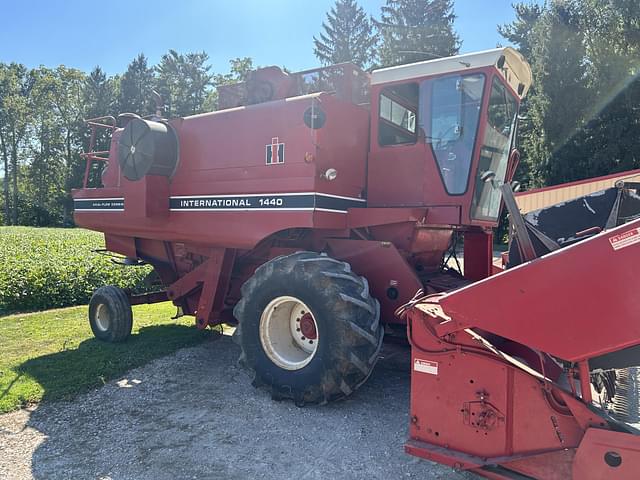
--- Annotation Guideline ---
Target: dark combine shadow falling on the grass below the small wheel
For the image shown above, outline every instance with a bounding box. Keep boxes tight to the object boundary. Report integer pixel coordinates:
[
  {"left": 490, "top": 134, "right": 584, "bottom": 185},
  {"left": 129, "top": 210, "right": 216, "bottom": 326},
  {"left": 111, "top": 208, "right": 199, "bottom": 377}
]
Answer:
[{"left": 15, "top": 325, "right": 216, "bottom": 401}]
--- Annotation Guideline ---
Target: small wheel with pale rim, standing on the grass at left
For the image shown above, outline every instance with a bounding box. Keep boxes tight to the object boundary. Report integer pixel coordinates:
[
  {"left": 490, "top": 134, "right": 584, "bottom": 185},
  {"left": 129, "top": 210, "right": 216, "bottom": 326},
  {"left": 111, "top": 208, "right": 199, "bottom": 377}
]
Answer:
[{"left": 89, "top": 285, "right": 133, "bottom": 343}]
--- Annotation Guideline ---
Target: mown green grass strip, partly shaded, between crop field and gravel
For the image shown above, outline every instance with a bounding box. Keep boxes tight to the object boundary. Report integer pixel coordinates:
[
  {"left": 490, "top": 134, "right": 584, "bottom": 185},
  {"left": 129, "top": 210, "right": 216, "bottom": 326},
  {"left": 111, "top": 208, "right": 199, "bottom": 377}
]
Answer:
[{"left": 0, "top": 302, "right": 212, "bottom": 413}]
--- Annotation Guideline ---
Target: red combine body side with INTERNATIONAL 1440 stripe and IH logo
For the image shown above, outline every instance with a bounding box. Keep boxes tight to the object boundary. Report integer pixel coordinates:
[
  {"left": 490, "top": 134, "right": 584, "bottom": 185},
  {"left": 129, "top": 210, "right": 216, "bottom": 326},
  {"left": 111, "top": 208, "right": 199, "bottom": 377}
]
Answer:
[{"left": 73, "top": 93, "right": 369, "bottom": 249}]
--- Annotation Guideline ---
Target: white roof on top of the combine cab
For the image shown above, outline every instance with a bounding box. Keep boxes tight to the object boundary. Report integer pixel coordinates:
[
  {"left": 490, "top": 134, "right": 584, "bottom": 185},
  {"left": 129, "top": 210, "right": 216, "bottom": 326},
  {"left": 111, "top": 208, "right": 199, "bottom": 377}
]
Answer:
[{"left": 371, "top": 47, "right": 532, "bottom": 98}]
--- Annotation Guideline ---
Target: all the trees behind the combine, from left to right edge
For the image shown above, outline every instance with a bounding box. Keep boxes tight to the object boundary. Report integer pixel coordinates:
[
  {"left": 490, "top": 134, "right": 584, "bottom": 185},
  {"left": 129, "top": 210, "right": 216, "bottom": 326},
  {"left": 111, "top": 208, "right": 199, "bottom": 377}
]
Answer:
[{"left": 0, "top": 0, "right": 640, "bottom": 225}]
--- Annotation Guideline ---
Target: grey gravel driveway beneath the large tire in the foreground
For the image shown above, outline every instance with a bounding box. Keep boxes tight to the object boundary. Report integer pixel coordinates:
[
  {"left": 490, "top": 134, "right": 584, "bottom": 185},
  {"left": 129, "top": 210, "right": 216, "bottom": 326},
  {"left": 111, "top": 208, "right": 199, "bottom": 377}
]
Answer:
[{"left": 0, "top": 336, "right": 471, "bottom": 480}]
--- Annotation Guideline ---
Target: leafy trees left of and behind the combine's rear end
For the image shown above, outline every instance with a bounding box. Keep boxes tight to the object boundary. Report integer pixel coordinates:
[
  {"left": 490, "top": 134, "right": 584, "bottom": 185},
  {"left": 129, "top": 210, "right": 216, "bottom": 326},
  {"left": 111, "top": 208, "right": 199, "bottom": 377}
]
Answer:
[{"left": 0, "top": 50, "right": 253, "bottom": 226}]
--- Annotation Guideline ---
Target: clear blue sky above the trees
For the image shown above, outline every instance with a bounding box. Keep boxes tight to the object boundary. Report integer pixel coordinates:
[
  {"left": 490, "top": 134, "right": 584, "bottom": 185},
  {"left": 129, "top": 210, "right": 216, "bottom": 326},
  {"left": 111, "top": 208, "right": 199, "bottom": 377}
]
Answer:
[{"left": 0, "top": 0, "right": 514, "bottom": 74}]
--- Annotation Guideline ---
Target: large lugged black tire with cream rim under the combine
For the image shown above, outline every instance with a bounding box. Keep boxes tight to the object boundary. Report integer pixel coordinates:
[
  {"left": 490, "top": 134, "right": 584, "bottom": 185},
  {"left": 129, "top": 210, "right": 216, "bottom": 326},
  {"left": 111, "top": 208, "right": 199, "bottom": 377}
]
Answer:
[{"left": 233, "top": 252, "right": 384, "bottom": 405}]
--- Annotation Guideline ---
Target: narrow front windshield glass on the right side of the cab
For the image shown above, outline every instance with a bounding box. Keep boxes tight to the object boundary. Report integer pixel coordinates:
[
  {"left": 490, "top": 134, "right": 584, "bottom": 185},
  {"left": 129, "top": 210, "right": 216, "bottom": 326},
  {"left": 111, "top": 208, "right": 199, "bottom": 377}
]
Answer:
[{"left": 471, "top": 77, "right": 518, "bottom": 221}]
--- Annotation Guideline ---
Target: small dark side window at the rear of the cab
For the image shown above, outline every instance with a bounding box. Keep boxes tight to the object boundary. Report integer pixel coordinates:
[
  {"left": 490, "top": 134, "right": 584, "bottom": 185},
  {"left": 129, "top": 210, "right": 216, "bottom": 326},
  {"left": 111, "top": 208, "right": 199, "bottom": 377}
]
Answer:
[{"left": 378, "top": 83, "right": 418, "bottom": 146}]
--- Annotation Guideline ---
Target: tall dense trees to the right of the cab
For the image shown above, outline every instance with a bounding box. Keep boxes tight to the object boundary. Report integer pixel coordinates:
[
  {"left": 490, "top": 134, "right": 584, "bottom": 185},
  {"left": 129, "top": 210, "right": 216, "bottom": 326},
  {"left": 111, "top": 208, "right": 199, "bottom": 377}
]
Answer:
[{"left": 499, "top": 0, "right": 640, "bottom": 186}]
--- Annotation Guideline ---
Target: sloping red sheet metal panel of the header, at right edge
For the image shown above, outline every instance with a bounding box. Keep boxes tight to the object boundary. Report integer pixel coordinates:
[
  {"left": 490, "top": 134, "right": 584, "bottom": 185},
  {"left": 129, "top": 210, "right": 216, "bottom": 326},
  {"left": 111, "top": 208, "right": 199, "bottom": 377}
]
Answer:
[{"left": 440, "top": 220, "right": 640, "bottom": 361}]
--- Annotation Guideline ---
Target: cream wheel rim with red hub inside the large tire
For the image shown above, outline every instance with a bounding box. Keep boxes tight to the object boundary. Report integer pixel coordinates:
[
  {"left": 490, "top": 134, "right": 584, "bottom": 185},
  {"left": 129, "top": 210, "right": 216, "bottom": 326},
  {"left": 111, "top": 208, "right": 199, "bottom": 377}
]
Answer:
[{"left": 260, "top": 296, "right": 319, "bottom": 370}]
